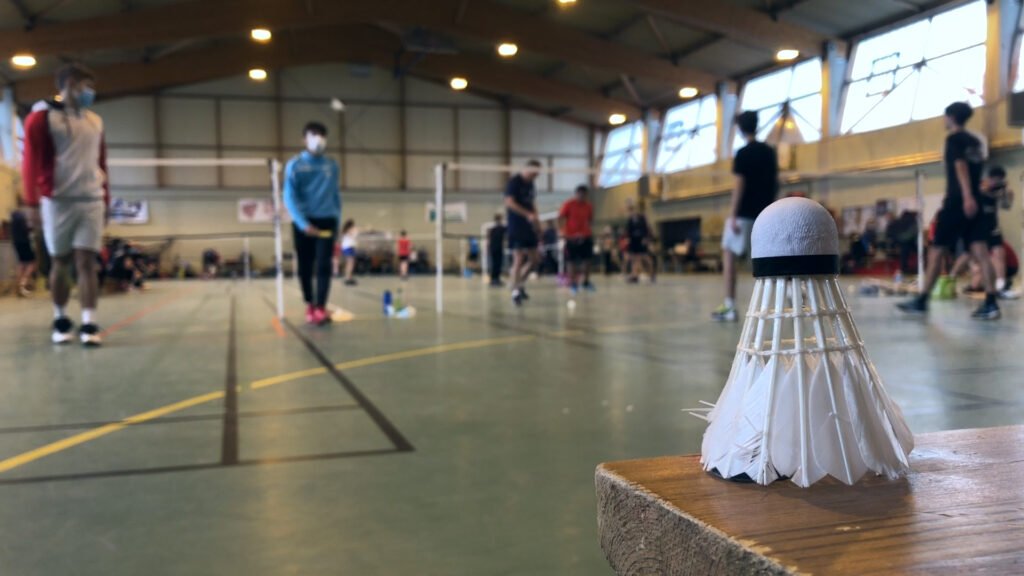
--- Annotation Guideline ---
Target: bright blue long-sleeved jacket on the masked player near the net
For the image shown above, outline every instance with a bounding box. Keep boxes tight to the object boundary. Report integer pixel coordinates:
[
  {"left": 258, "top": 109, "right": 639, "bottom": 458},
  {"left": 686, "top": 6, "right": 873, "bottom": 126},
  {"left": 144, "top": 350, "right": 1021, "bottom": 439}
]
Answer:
[{"left": 285, "top": 151, "right": 341, "bottom": 230}]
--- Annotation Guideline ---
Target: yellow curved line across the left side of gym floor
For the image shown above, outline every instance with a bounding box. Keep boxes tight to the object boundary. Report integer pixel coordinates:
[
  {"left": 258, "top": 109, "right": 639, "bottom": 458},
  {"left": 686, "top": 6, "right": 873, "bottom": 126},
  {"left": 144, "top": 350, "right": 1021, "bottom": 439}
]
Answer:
[{"left": 0, "top": 336, "right": 537, "bottom": 474}]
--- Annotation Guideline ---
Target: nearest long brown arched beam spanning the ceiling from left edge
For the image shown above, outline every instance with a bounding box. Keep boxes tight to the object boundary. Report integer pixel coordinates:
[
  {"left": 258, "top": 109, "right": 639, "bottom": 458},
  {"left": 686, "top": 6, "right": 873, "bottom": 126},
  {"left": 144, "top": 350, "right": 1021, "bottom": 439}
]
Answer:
[{"left": 0, "top": 0, "right": 720, "bottom": 89}]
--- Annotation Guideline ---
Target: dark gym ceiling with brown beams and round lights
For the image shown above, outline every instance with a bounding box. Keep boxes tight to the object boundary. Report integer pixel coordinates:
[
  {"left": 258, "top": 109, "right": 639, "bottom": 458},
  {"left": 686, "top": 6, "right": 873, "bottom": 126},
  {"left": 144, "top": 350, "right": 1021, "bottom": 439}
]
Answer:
[{"left": 0, "top": 0, "right": 951, "bottom": 125}]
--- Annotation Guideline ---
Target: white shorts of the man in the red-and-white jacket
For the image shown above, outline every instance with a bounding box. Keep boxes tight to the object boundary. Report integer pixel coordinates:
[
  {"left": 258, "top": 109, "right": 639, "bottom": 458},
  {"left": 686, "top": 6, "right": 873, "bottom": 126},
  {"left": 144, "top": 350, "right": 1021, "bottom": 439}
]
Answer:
[{"left": 39, "top": 198, "right": 106, "bottom": 256}]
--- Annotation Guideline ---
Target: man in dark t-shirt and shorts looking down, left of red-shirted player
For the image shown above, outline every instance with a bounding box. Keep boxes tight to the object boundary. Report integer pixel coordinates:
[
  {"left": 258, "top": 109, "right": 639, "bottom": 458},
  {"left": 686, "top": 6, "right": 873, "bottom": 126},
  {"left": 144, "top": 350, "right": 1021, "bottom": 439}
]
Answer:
[{"left": 505, "top": 160, "right": 541, "bottom": 305}]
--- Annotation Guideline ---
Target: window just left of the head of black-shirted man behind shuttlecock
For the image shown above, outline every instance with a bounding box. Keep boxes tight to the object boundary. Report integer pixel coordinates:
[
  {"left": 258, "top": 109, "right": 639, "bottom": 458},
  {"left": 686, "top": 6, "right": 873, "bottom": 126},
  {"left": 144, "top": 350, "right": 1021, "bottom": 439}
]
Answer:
[{"left": 656, "top": 95, "right": 718, "bottom": 173}]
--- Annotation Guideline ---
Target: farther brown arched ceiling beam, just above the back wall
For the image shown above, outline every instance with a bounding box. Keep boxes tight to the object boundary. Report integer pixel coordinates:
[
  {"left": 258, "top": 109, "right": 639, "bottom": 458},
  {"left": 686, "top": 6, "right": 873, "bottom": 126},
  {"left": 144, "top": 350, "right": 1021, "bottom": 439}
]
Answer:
[{"left": 14, "top": 27, "right": 640, "bottom": 117}]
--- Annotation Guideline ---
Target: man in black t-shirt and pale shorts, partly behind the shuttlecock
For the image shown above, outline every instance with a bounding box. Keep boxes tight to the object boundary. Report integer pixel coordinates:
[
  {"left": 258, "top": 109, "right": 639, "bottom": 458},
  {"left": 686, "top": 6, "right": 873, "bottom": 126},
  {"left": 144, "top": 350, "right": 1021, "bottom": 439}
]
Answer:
[{"left": 712, "top": 112, "right": 778, "bottom": 322}]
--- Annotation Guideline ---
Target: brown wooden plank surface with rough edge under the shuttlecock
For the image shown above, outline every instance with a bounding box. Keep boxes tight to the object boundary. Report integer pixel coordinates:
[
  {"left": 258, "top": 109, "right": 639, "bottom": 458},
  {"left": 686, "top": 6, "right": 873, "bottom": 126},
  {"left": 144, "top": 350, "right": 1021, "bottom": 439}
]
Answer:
[{"left": 596, "top": 426, "right": 1024, "bottom": 576}]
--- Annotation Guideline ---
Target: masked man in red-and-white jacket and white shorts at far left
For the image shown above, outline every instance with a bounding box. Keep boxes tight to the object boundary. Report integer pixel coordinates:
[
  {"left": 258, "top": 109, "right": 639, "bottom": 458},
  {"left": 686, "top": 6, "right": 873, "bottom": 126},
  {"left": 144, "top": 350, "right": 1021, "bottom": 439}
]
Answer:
[{"left": 22, "top": 64, "right": 110, "bottom": 346}]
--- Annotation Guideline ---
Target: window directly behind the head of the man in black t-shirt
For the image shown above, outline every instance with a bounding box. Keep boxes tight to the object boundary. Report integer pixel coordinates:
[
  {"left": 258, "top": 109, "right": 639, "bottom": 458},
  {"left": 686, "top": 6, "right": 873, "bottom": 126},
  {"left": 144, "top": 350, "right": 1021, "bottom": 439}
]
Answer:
[{"left": 732, "top": 58, "right": 821, "bottom": 154}]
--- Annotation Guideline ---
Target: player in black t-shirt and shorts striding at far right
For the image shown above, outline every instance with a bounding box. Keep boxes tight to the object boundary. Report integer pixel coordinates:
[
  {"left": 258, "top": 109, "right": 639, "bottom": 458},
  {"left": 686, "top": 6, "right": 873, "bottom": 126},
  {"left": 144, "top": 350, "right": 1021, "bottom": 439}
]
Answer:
[{"left": 898, "top": 102, "right": 1001, "bottom": 320}]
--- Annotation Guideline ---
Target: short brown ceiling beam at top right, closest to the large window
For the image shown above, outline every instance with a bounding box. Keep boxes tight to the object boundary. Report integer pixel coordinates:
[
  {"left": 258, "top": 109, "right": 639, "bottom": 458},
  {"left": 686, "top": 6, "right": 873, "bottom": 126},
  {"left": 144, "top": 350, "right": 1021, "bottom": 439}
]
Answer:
[{"left": 632, "top": 0, "right": 836, "bottom": 55}]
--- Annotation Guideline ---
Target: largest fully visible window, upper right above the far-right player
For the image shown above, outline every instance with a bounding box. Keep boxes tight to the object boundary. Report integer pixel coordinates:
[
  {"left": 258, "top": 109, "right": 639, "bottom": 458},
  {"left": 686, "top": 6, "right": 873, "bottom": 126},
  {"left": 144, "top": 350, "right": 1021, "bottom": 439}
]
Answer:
[{"left": 842, "top": 0, "right": 988, "bottom": 133}]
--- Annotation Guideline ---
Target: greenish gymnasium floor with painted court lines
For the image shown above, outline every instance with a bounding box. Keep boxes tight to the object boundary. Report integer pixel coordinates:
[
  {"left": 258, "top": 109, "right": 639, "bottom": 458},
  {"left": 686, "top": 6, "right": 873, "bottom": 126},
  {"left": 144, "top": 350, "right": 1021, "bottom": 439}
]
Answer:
[{"left": 0, "top": 277, "right": 1024, "bottom": 576}]
